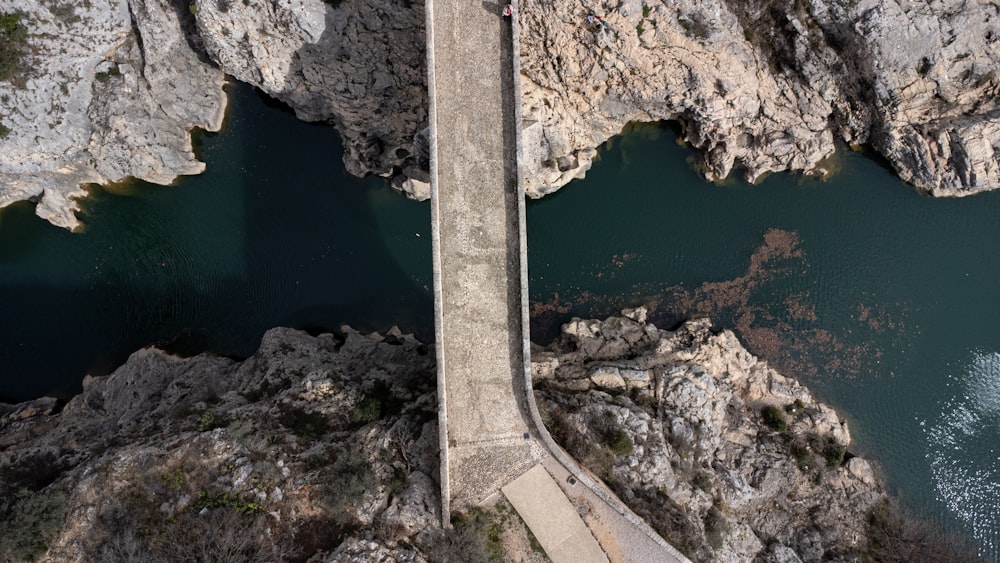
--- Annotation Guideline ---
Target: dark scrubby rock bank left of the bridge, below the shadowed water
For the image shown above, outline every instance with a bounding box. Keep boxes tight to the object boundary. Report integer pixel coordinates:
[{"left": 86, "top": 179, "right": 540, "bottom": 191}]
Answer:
[{"left": 0, "top": 329, "right": 440, "bottom": 562}]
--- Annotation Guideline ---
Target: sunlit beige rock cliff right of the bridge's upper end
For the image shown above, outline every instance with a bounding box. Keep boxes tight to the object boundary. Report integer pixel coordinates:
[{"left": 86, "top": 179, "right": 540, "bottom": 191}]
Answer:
[{"left": 521, "top": 0, "right": 1000, "bottom": 196}]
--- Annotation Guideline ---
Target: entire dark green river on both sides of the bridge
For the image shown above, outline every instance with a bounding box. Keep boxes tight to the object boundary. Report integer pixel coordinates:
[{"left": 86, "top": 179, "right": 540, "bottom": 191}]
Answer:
[{"left": 0, "top": 87, "right": 1000, "bottom": 560}]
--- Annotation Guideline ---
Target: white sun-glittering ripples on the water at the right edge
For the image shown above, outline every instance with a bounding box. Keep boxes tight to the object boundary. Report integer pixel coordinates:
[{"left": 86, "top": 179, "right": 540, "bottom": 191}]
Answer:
[{"left": 921, "top": 352, "right": 1000, "bottom": 561}]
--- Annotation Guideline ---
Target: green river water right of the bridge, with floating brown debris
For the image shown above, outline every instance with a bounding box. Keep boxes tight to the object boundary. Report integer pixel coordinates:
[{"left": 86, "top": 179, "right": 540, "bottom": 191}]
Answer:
[{"left": 528, "top": 126, "right": 1000, "bottom": 560}]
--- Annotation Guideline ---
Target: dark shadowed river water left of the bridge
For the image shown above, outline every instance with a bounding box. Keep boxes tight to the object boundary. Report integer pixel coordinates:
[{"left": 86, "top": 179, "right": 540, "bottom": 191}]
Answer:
[{"left": 0, "top": 82, "right": 433, "bottom": 401}]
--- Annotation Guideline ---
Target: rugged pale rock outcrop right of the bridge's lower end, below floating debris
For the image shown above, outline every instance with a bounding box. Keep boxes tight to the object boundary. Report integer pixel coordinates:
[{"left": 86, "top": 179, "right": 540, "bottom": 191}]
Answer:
[{"left": 532, "top": 309, "right": 885, "bottom": 561}]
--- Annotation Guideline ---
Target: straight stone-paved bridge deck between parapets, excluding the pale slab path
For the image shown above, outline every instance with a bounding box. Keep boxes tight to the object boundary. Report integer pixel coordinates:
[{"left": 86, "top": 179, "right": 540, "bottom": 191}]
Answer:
[{"left": 428, "top": 0, "right": 542, "bottom": 510}]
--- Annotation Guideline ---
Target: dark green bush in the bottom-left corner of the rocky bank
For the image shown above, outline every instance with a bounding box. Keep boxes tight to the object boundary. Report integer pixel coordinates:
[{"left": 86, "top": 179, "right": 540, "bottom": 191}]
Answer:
[{"left": 0, "top": 489, "right": 66, "bottom": 561}]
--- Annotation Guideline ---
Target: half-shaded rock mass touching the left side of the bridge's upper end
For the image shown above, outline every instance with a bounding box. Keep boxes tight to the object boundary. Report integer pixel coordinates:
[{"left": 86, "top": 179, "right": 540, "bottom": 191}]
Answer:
[{"left": 194, "top": 0, "right": 430, "bottom": 199}]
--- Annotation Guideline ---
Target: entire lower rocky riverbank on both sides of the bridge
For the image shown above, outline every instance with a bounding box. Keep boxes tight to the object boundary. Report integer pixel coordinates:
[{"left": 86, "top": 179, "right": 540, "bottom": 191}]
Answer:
[{"left": 0, "top": 316, "right": 968, "bottom": 561}]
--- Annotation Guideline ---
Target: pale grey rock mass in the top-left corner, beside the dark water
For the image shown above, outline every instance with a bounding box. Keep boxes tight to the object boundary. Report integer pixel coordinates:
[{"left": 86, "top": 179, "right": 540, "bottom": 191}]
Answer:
[{"left": 0, "top": 0, "right": 225, "bottom": 228}]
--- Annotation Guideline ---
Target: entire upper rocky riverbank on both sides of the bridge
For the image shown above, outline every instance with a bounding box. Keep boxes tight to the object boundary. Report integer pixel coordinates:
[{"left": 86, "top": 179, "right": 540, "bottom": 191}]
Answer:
[{"left": 0, "top": 0, "right": 1000, "bottom": 227}]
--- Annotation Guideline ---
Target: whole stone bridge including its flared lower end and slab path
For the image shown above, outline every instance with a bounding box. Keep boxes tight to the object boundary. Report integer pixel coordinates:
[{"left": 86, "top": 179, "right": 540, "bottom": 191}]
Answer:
[{"left": 425, "top": 0, "right": 687, "bottom": 563}]
